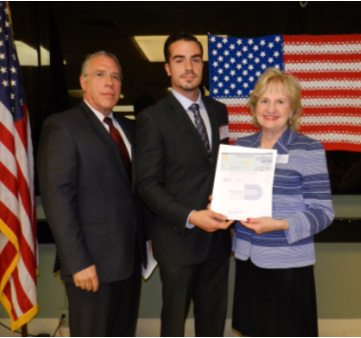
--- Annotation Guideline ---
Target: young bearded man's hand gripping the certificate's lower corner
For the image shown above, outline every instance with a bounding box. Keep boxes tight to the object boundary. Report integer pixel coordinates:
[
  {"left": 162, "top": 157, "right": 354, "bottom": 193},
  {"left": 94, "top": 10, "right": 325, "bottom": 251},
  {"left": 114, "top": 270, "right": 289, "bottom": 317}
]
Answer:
[{"left": 189, "top": 210, "right": 233, "bottom": 232}]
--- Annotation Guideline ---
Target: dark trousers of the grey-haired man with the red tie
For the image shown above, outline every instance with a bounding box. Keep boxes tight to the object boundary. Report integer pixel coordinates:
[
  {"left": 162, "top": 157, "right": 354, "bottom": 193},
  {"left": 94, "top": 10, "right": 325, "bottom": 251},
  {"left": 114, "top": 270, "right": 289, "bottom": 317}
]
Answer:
[{"left": 65, "top": 264, "right": 141, "bottom": 337}]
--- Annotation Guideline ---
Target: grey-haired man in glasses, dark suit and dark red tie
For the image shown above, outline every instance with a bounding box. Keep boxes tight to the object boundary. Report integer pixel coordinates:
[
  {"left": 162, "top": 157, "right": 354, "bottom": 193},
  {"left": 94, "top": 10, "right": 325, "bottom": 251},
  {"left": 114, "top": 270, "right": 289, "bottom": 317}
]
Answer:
[{"left": 37, "top": 52, "right": 145, "bottom": 337}]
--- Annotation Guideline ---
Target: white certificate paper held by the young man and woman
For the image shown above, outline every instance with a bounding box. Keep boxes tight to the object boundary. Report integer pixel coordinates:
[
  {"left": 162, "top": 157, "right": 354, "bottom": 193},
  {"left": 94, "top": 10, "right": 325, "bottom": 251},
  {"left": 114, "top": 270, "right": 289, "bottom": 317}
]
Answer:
[{"left": 211, "top": 144, "right": 277, "bottom": 221}]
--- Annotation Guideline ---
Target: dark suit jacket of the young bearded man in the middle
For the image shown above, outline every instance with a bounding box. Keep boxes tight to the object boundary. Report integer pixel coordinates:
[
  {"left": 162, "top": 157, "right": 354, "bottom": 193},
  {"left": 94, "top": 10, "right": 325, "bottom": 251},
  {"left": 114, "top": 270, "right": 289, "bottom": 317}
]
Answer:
[{"left": 136, "top": 94, "right": 230, "bottom": 265}]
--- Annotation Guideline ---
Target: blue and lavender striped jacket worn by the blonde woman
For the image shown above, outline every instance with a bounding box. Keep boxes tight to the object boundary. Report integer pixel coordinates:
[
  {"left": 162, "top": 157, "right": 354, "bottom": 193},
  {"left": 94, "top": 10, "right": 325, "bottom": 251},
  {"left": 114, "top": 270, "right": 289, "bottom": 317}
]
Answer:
[{"left": 233, "top": 129, "right": 334, "bottom": 268}]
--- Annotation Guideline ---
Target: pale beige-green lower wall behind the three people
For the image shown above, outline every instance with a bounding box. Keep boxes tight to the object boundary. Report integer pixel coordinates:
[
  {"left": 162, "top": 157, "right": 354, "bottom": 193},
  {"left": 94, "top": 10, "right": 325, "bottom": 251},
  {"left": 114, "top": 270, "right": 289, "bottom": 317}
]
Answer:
[{"left": 0, "top": 196, "right": 361, "bottom": 319}]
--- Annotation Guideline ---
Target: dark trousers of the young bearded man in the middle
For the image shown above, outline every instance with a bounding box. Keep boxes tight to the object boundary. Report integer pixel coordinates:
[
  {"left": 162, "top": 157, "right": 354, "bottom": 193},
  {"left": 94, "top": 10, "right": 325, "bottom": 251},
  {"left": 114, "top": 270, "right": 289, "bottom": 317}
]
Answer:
[{"left": 159, "top": 246, "right": 229, "bottom": 337}]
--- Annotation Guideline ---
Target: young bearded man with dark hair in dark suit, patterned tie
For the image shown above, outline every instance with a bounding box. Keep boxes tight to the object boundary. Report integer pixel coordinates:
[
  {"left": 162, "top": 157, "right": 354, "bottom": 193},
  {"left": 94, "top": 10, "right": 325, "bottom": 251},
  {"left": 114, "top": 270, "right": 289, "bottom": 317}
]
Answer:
[{"left": 136, "top": 33, "right": 231, "bottom": 336}]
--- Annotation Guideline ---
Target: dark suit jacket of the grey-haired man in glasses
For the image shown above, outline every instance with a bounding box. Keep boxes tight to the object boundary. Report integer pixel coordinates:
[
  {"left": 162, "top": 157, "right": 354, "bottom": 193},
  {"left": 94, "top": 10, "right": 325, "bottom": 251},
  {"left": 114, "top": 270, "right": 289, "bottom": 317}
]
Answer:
[{"left": 37, "top": 102, "right": 144, "bottom": 282}]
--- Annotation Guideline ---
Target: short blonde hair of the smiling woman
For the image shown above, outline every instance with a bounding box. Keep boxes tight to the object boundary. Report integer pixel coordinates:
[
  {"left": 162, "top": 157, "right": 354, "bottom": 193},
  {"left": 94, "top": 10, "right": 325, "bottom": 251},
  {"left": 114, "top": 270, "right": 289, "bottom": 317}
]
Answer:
[{"left": 248, "top": 68, "right": 302, "bottom": 131}]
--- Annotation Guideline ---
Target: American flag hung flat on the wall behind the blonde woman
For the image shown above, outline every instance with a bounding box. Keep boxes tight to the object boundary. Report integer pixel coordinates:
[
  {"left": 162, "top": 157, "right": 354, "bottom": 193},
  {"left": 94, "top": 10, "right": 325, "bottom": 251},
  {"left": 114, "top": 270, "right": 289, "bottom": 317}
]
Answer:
[{"left": 208, "top": 35, "right": 361, "bottom": 152}]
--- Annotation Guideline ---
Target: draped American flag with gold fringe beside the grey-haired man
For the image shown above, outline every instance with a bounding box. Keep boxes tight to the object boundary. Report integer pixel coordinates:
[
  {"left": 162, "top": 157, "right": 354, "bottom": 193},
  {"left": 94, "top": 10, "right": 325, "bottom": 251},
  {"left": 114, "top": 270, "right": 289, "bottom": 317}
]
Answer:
[{"left": 0, "top": 1, "right": 38, "bottom": 330}]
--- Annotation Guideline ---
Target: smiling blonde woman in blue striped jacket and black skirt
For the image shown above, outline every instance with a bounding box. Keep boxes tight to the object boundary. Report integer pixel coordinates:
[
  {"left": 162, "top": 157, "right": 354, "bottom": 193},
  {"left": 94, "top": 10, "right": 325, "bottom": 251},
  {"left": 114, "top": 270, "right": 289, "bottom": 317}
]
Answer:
[{"left": 233, "top": 68, "right": 334, "bottom": 336}]
